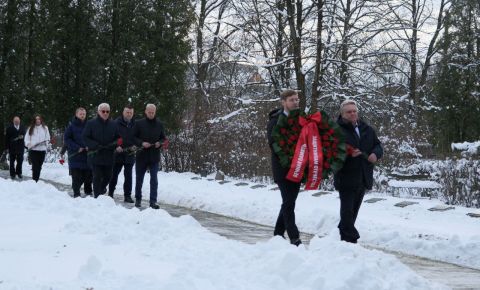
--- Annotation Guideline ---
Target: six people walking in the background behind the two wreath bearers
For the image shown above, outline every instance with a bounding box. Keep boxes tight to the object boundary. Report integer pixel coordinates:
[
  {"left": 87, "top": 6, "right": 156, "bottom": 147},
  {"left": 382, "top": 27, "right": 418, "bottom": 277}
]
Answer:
[{"left": 2, "top": 103, "right": 168, "bottom": 209}]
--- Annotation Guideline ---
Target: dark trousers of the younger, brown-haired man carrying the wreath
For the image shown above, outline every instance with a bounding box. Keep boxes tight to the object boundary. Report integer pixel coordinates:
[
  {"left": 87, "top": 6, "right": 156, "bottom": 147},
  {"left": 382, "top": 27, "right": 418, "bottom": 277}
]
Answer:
[{"left": 273, "top": 180, "right": 300, "bottom": 242}]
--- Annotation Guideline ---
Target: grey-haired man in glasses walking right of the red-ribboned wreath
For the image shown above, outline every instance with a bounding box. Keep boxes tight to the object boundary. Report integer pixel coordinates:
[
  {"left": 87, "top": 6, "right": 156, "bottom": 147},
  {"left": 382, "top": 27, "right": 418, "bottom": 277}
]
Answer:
[{"left": 334, "top": 100, "right": 383, "bottom": 243}]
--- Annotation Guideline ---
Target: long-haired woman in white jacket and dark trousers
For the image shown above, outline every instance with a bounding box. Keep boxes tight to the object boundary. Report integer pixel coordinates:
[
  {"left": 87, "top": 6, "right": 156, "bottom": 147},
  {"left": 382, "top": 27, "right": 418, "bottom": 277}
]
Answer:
[{"left": 25, "top": 115, "right": 50, "bottom": 182}]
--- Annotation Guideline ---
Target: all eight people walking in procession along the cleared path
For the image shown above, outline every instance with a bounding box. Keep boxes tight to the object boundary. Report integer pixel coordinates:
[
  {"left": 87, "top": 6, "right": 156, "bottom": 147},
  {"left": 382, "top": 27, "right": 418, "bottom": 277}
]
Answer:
[{"left": 6, "top": 90, "right": 383, "bottom": 246}]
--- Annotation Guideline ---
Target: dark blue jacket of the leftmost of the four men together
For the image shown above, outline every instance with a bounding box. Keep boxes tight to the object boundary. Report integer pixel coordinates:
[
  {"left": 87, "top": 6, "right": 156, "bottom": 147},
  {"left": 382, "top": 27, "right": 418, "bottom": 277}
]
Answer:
[{"left": 63, "top": 117, "right": 89, "bottom": 169}]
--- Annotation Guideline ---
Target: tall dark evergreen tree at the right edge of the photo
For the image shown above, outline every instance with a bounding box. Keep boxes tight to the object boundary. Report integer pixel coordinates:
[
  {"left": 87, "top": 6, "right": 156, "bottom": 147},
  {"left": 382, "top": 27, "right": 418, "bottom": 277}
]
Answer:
[{"left": 431, "top": 0, "right": 480, "bottom": 152}]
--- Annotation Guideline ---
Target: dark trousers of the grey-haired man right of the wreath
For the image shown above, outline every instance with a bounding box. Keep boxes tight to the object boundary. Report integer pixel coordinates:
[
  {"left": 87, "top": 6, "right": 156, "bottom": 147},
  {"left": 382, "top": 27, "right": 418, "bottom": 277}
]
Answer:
[{"left": 338, "top": 185, "right": 365, "bottom": 243}]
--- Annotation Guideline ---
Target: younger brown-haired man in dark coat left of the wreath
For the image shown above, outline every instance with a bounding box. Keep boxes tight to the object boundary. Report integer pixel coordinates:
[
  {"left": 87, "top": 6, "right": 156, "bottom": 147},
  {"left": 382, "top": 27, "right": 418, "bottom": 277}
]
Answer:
[{"left": 267, "top": 90, "right": 302, "bottom": 246}]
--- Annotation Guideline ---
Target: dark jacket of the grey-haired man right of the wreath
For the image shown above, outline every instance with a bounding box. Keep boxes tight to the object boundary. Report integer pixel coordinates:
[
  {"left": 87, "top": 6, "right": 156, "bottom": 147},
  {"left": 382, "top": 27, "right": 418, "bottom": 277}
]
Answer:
[{"left": 334, "top": 117, "right": 383, "bottom": 190}]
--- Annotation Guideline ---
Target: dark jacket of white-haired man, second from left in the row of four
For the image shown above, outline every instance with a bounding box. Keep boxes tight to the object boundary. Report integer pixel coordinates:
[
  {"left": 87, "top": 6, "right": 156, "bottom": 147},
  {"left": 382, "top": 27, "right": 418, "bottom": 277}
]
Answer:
[{"left": 82, "top": 116, "right": 119, "bottom": 166}]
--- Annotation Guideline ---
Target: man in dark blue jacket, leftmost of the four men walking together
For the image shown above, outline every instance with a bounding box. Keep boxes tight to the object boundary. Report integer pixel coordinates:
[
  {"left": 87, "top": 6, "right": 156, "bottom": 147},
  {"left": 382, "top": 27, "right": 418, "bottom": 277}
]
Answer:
[{"left": 63, "top": 108, "right": 93, "bottom": 197}]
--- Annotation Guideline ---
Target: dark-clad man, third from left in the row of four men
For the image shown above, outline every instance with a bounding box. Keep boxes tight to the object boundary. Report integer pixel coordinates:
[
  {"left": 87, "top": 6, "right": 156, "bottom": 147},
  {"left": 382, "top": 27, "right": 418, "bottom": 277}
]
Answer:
[{"left": 108, "top": 105, "right": 136, "bottom": 203}]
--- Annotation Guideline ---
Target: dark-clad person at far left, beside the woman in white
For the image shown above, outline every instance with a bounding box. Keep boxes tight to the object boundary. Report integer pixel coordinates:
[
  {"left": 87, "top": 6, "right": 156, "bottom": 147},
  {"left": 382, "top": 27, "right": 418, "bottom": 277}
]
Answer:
[{"left": 5, "top": 116, "right": 26, "bottom": 179}]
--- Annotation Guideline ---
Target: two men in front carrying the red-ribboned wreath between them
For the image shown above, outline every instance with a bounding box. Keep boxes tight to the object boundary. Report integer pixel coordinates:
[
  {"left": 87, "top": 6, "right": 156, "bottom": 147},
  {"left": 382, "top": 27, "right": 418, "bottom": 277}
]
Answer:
[{"left": 267, "top": 90, "right": 383, "bottom": 246}]
